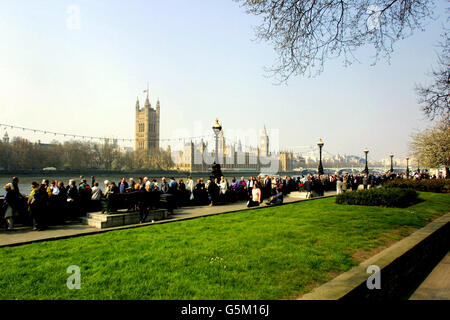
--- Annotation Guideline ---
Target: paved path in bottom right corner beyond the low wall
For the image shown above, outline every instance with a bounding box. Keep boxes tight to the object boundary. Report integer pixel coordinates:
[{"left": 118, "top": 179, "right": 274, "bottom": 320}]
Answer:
[{"left": 409, "top": 251, "right": 450, "bottom": 300}]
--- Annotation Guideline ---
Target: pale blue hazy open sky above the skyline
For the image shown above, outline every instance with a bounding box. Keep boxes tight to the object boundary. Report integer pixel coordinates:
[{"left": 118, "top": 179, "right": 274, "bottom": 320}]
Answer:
[{"left": 0, "top": 0, "right": 448, "bottom": 159}]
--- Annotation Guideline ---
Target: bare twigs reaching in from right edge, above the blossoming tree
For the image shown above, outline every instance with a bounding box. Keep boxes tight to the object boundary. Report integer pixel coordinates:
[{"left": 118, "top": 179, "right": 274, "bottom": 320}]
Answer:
[{"left": 416, "top": 30, "right": 450, "bottom": 121}]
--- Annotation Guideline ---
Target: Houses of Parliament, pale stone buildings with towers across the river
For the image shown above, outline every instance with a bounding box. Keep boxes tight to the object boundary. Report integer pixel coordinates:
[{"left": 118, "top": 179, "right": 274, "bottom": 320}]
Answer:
[{"left": 135, "top": 92, "right": 293, "bottom": 172}]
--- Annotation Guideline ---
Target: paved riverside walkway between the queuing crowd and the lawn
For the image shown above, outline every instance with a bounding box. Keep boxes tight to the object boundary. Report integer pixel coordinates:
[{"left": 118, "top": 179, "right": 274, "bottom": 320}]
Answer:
[{"left": 0, "top": 191, "right": 336, "bottom": 248}]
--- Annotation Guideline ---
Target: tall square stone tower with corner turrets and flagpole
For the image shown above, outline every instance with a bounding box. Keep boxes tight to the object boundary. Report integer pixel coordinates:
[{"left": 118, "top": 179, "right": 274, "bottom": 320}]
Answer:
[{"left": 135, "top": 92, "right": 160, "bottom": 152}]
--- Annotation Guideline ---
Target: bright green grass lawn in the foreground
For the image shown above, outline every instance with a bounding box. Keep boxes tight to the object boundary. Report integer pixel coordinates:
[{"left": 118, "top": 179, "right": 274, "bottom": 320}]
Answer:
[{"left": 0, "top": 193, "right": 450, "bottom": 299}]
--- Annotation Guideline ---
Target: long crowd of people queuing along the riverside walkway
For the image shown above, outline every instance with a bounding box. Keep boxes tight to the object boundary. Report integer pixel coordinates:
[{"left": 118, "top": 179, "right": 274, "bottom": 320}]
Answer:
[{"left": 0, "top": 171, "right": 442, "bottom": 230}]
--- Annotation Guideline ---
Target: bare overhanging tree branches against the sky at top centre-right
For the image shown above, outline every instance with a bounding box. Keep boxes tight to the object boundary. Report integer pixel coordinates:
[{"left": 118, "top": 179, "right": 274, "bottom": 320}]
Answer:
[{"left": 234, "top": 0, "right": 434, "bottom": 82}]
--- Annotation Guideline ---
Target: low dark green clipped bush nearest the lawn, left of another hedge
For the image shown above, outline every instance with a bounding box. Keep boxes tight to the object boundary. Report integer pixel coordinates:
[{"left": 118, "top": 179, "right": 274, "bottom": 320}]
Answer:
[{"left": 336, "top": 188, "right": 418, "bottom": 208}]
